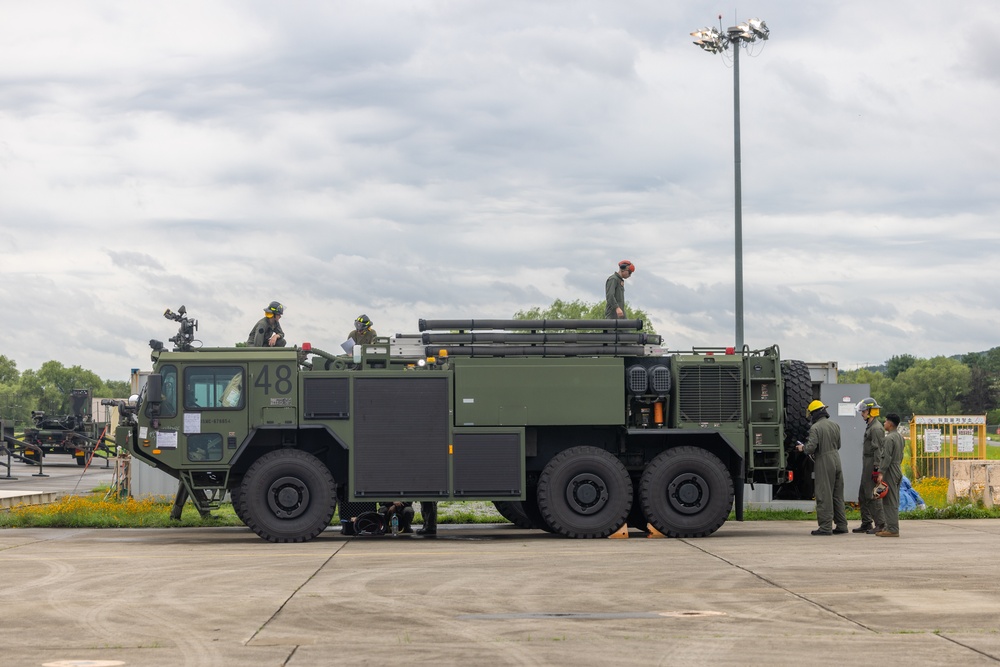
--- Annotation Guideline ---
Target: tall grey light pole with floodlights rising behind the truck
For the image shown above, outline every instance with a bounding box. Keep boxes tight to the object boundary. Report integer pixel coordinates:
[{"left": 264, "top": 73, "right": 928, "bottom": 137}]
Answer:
[{"left": 691, "top": 14, "right": 771, "bottom": 350}]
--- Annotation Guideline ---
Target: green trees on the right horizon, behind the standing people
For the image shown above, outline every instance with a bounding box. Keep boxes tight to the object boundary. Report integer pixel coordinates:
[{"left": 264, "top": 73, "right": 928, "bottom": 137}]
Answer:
[{"left": 838, "top": 347, "right": 1000, "bottom": 424}]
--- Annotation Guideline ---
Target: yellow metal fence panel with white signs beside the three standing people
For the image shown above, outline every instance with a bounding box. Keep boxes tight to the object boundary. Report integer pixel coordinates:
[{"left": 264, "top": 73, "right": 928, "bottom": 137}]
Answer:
[{"left": 910, "top": 415, "right": 986, "bottom": 479}]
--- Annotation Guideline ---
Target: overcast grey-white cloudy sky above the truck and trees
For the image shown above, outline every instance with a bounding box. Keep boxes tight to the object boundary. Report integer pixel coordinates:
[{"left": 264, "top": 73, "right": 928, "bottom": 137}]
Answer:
[{"left": 0, "top": 0, "right": 1000, "bottom": 379}]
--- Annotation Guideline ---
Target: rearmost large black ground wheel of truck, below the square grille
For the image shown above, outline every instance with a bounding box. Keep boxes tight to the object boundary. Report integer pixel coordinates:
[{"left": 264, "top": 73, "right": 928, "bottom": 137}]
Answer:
[{"left": 639, "top": 447, "right": 735, "bottom": 537}]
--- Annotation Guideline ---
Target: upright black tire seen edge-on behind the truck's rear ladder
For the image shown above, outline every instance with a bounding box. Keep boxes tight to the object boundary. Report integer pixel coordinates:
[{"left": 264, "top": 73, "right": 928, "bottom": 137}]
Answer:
[{"left": 774, "top": 360, "right": 815, "bottom": 500}]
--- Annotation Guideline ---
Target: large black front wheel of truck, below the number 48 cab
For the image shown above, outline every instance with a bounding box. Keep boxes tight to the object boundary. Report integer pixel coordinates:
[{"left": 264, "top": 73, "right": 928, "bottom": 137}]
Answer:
[{"left": 238, "top": 449, "right": 337, "bottom": 542}]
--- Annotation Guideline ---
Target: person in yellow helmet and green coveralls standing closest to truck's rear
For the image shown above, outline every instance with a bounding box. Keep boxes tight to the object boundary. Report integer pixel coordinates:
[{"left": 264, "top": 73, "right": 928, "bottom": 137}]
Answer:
[{"left": 795, "top": 401, "right": 847, "bottom": 535}]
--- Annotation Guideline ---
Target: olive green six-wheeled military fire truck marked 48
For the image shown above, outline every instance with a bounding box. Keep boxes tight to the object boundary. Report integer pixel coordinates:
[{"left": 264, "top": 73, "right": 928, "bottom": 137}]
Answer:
[{"left": 116, "top": 310, "right": 811, "bottom": 542}]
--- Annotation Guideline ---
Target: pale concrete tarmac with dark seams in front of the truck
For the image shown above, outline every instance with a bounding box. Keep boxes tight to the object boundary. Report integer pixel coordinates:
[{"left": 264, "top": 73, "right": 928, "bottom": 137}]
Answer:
[{"left": 0, "top": 520, "right": 1000, "bottom": 667}]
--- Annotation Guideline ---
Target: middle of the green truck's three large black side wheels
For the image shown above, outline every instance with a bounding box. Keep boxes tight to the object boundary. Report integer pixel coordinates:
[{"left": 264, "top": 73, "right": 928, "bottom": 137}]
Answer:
[{"left": 538, "top": 447, "right": 632, "bottom": 538}]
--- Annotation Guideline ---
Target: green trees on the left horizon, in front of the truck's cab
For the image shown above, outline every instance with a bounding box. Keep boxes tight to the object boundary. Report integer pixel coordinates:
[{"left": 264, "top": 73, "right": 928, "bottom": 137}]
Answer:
[{"left": 0, "top": 355, "right": 131, "bottom": 427}]
